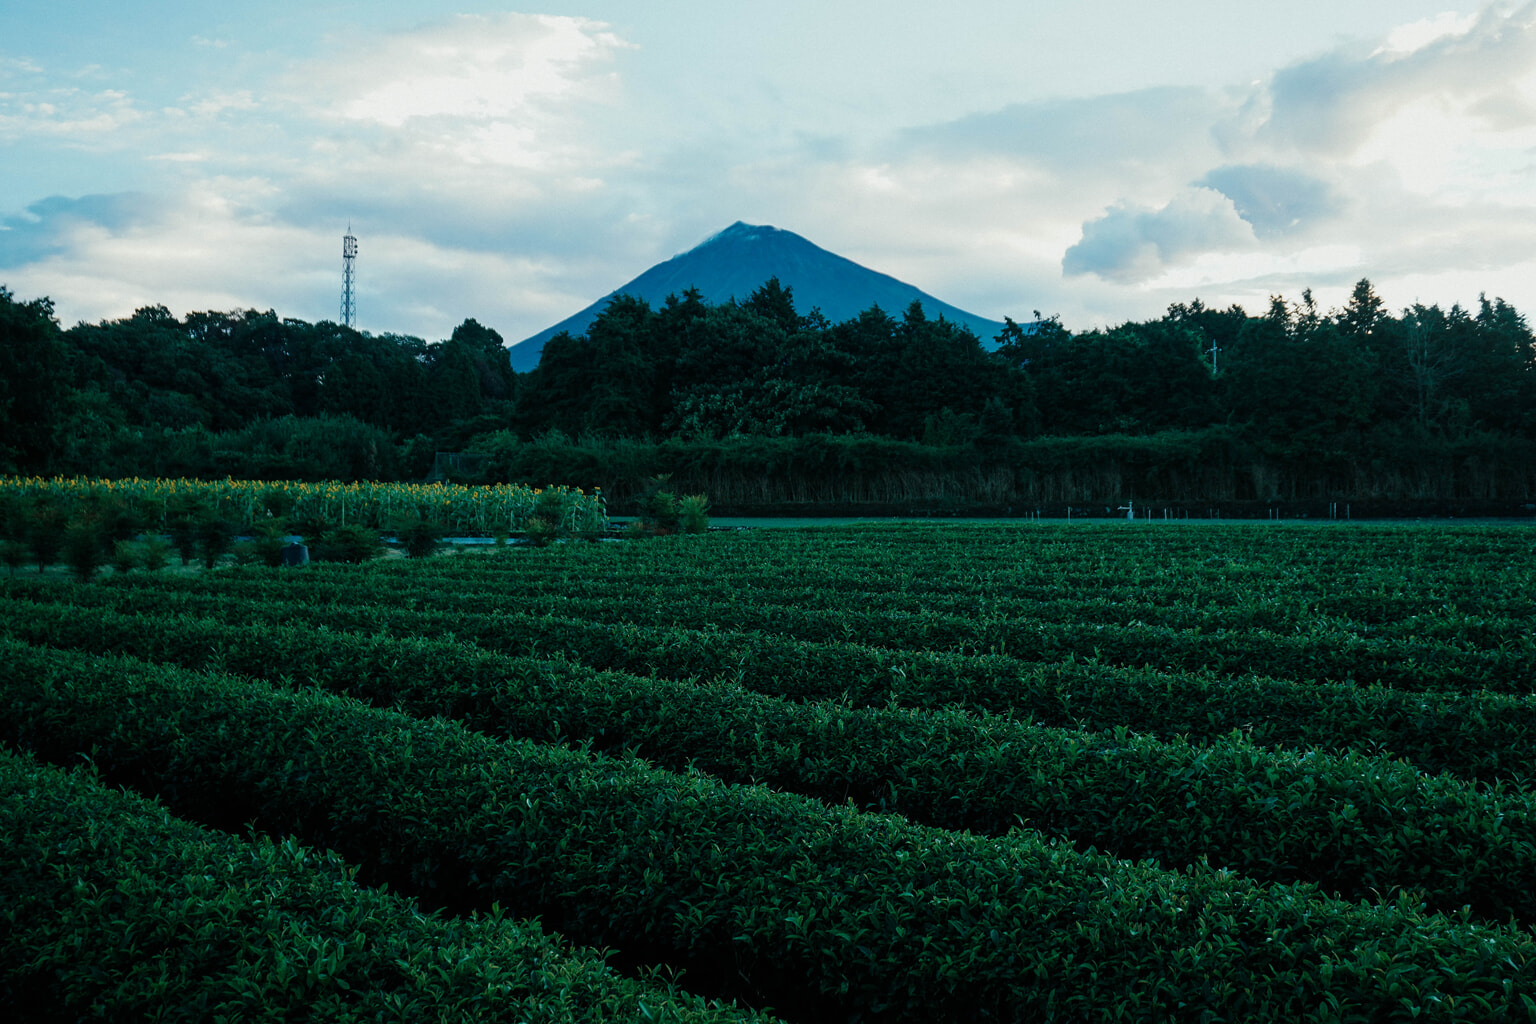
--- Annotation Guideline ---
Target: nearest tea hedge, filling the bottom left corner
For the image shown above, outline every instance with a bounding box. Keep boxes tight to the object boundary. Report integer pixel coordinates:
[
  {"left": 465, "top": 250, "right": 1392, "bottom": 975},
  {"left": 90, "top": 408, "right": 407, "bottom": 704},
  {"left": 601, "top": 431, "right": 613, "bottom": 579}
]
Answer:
[{"left": 0, "top": 749, "right": 759, "bottom": 1024}]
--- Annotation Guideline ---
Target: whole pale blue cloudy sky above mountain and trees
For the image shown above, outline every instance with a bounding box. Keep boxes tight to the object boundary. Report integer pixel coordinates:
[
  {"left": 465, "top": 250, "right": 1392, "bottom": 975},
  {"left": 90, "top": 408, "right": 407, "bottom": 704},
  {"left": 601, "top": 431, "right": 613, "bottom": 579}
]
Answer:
[{"left": 0, "top": 0, "right": 1536, "bottom": 342}]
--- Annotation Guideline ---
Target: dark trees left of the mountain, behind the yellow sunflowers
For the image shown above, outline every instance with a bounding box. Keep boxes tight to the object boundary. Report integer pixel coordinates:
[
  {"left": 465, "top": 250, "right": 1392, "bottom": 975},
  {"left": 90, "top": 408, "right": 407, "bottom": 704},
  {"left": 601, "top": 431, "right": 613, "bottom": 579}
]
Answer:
[{"left": 0, "top": 289, "right": 518, "bottom": 479}]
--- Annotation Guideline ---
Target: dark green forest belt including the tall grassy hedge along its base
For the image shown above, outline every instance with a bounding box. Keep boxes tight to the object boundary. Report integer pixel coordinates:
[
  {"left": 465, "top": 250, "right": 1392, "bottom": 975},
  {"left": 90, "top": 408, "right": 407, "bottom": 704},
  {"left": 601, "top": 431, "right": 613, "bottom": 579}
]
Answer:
[{"left": 0, "top": 279, "right": 1536, "bottom": 514}]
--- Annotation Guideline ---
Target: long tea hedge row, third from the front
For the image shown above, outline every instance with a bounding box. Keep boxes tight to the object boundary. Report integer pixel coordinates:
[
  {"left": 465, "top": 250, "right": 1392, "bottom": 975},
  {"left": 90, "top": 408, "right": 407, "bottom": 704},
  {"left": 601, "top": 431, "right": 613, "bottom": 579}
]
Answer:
[{"left": 5, "top": 603, "right": 1536, "bottom": 921}]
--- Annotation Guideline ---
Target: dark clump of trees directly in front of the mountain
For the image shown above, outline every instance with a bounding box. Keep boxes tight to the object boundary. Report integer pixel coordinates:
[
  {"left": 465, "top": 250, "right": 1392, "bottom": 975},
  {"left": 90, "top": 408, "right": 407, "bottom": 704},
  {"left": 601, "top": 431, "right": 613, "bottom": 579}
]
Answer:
[{"left": 515, "top": 279, "right": 1034, "bottom": 439}]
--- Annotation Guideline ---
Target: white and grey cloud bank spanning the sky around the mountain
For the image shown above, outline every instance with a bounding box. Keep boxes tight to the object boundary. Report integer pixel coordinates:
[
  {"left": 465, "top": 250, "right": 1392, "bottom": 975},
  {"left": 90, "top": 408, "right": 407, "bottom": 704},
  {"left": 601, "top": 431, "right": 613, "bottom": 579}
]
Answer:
[{"left": 0, "top": 3, "right": 1536, "bottom": 339}]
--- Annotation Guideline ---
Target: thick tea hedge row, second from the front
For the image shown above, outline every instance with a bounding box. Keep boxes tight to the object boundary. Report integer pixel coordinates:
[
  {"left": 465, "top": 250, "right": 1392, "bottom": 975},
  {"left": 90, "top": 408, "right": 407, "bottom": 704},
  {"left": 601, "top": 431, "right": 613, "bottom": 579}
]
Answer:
[{"left": 0, "top": 642, "right": 1536, "bottom": 1021}]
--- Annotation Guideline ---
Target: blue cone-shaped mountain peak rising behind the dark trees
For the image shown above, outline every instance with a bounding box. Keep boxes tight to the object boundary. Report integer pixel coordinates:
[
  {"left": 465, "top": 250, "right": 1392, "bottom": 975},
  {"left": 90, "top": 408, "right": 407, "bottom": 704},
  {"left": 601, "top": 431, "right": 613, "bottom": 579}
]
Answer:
[{"left": 510, "top": 221, "right": 1003, "bottom": 372}]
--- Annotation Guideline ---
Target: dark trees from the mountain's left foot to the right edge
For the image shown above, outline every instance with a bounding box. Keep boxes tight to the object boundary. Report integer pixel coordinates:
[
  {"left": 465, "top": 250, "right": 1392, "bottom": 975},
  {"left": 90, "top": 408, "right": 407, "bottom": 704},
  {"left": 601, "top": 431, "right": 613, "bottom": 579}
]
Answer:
[{"left": 515, "top": 281, "right": 1536, "bottom": 456}]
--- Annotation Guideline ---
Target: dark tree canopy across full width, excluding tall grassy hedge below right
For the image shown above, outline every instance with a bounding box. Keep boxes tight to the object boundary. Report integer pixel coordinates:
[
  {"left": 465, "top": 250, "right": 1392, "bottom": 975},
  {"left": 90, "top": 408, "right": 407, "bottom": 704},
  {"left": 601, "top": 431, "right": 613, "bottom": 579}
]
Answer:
[{"left": 0, "top": 279, "right": 1536, "bottom": 494}]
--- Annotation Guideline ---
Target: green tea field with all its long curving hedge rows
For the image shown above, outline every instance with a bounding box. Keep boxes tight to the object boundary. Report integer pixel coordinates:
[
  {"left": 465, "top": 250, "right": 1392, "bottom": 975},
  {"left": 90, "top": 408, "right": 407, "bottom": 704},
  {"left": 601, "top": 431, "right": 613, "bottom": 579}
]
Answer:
[{"left": 0, "top": 522, "right": 1536, "bottom": 1022}]
